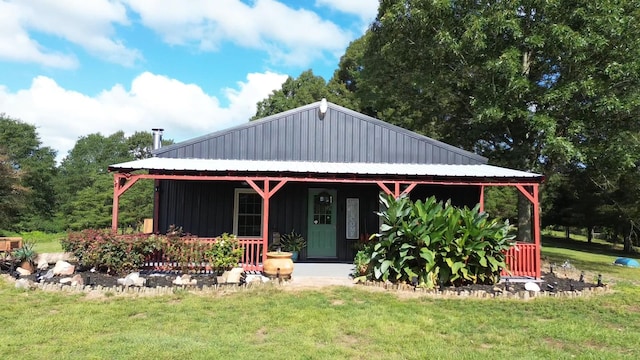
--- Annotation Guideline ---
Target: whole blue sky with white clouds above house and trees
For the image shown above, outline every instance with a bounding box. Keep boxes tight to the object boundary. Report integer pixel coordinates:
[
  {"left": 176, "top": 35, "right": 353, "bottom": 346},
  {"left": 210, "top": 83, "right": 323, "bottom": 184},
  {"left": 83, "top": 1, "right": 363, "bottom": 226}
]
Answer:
[{"left": 0, "top": 0, "right": 378, "bottom": 160}]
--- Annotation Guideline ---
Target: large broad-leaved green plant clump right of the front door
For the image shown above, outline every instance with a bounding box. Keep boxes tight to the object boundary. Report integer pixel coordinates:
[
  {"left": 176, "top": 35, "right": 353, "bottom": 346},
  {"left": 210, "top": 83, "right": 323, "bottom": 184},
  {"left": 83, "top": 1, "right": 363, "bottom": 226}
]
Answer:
[{"left": 365, "top": 195, "right": 514, "bottom": 288}]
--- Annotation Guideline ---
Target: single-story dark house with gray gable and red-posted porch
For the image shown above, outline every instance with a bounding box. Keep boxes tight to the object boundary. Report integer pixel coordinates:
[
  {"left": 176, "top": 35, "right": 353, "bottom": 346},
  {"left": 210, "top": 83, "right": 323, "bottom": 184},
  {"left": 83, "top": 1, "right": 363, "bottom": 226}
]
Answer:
[{"left": 109, "top": 99, "right": 543, "bottom": 278}]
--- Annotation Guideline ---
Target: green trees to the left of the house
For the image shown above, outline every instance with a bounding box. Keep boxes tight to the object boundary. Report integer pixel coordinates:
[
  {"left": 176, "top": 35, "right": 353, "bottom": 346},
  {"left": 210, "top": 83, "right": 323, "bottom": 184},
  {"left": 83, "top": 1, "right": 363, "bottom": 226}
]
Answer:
[{"left": 0, "top": 114, "right": 171, "bottom": 234}]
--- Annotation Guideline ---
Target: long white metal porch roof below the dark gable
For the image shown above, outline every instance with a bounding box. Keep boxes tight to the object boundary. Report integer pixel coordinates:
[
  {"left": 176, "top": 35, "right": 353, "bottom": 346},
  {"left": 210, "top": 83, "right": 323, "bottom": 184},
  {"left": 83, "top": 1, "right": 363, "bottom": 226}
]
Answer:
[{"left": 109, "top": 157, "right": 543, "bottom": 181}]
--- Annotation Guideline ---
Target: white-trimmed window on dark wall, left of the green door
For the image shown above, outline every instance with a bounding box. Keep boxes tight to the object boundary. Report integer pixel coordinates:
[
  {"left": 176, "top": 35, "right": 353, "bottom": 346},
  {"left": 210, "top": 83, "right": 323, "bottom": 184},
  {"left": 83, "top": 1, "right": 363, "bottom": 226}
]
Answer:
[{"left": 233, "top": 189, "right": 262, "bottom": 238}]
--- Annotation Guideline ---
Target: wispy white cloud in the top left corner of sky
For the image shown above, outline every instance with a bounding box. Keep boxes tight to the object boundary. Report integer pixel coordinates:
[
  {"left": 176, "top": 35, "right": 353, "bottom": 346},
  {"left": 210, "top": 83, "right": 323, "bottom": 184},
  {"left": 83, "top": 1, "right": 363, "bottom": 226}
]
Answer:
[{"left": 0, "top": 0, "right": 142, "bottom": 68}]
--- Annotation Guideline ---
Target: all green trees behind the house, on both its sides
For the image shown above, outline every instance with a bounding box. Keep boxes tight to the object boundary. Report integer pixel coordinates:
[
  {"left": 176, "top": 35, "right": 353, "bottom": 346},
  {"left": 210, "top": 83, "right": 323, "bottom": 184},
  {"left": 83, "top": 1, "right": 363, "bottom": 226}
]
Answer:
[{"left": 0, "top": 0, "right": 640, "bottom": 251}]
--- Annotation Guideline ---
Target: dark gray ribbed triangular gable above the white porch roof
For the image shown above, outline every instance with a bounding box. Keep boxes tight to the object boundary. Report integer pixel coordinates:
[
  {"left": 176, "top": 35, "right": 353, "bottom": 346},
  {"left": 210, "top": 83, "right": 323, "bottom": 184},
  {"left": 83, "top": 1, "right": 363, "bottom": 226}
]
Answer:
[{"left": 156, "top": 104, "right": 487, "bottom": 165}]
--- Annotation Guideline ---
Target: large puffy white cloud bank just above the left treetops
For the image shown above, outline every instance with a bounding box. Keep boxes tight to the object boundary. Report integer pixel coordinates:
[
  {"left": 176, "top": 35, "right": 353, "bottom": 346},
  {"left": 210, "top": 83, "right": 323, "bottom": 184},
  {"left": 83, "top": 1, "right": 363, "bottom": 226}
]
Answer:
[{"left": 0, "top": 72, "right": 287, "bottom": 160}]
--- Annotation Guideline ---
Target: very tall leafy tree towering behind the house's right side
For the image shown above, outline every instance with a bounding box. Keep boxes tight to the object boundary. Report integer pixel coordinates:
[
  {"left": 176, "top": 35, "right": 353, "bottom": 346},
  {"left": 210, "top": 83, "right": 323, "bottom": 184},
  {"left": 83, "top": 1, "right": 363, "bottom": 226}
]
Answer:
[{"left": 357, "top": 0, "right": 640, "bottom": 245}]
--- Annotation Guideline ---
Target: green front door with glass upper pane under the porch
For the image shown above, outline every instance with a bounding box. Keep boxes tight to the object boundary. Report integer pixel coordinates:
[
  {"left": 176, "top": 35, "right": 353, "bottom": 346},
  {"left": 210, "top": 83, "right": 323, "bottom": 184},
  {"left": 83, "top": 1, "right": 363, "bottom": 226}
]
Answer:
[{"left": 307, "top": 189, "right": 337, "bottom": 258}]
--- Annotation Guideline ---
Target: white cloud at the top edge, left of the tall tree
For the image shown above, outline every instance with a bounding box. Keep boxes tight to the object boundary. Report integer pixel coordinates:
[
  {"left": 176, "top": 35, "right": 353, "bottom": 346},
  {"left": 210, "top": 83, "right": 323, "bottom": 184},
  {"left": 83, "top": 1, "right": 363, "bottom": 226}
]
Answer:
[{"left": 123, "top": 0, "right": 353, "bottom": 66}]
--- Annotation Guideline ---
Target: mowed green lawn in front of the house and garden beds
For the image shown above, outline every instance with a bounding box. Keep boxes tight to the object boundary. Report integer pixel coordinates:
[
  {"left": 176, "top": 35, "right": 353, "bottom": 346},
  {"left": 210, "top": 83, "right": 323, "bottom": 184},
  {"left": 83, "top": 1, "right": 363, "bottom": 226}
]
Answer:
[{"left": 0, "top": 283, "right": 640, "bottom": 359}]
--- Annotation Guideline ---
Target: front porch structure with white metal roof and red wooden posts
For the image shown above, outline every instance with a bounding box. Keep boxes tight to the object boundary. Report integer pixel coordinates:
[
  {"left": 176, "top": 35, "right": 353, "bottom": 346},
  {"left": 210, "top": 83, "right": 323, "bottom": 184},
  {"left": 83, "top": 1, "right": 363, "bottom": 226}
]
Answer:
[{"left": 110, "top": 158, "right": 541, "bottom": 278}]
